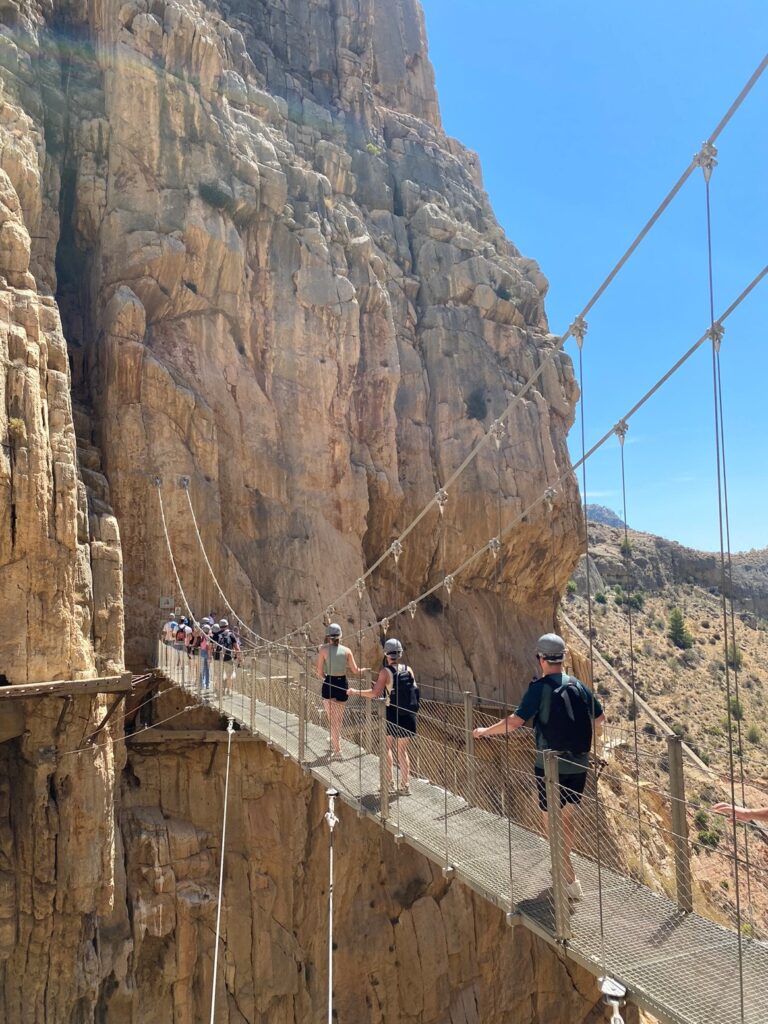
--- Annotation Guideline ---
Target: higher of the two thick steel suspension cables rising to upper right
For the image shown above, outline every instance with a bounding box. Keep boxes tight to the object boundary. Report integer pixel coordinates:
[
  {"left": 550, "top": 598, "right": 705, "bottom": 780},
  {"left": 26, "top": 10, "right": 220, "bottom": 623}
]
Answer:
[{"left": 281, "top": 54, "right": 768, "bottom": 640}]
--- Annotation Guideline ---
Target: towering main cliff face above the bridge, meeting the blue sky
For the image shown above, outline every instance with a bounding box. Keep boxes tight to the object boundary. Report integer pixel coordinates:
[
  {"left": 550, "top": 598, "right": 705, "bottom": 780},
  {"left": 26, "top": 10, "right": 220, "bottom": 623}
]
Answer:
[{"left": 2, "top": 0, "right": 579, "bottom": 688}]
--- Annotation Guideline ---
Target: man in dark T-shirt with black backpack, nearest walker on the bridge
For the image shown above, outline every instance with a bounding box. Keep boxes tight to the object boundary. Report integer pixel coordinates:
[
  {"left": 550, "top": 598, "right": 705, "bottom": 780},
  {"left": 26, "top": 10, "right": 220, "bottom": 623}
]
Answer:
[{"left": 474, "top": 633, "right": 605, "bottom": 899}]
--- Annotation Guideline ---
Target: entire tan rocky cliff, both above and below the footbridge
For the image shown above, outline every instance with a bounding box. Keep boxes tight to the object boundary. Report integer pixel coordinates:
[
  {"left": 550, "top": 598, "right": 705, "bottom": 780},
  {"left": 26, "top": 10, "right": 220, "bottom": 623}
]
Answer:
[{"left": 0, "top": 0, "right": 595, "bottom": 1024}]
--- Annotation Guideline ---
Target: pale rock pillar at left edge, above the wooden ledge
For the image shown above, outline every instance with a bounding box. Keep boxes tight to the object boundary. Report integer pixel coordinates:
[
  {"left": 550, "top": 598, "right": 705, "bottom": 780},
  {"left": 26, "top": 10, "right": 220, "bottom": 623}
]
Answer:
[{"left": 0, "top": 49, "right": 123, "bottom": 683}]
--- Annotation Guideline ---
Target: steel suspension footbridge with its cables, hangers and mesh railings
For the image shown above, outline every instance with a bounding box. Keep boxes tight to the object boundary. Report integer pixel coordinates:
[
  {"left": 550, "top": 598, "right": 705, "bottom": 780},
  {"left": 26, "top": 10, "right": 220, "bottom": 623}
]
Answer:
[{"left": 72, "top": 51, "right": 768, "bottom": 1024}]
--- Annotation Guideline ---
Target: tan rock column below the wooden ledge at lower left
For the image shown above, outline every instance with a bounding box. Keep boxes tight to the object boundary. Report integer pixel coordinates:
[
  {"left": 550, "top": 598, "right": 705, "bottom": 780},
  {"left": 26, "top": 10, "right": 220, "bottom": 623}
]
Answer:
[{"left": 0, "top": 697, "right": 121, "bottom": 1024}]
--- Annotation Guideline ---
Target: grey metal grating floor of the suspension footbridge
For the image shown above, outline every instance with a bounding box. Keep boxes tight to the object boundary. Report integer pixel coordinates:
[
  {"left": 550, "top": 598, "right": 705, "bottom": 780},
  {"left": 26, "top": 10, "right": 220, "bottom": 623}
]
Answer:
[{"left": 176, "top": 679, "right": 768, "bottom": 1024}]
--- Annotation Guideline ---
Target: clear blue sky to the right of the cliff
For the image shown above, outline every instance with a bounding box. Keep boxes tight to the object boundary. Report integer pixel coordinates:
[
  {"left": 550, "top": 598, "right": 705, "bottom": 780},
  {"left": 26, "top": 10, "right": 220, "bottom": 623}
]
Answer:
[{"left": 422, "top": 0, "right": 768, "bottom": 551}]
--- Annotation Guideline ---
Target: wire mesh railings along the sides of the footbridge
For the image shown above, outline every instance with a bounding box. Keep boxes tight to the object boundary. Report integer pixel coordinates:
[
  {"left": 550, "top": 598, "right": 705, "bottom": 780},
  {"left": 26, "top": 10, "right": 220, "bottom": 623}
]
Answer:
[{"left": 158, "top": 642, "right": 768, "bottom": 1024}]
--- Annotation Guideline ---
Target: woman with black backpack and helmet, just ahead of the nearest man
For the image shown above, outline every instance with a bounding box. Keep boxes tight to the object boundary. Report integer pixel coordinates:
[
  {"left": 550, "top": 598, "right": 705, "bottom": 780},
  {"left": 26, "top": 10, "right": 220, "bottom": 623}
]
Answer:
[{"left": 349, "top": 637, "right": 419, "bottom": 796}]
